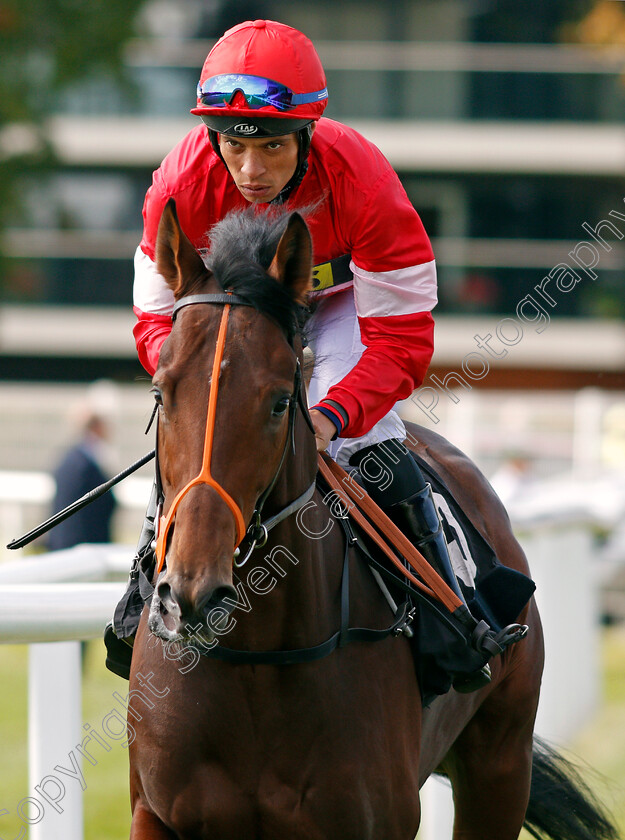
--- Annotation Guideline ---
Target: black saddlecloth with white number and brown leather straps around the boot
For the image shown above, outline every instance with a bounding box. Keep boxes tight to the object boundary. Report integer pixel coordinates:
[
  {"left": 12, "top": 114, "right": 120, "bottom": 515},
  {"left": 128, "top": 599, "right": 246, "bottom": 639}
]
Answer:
[{"left": 319, "top": 453, "right": 535, "bottom": 706}]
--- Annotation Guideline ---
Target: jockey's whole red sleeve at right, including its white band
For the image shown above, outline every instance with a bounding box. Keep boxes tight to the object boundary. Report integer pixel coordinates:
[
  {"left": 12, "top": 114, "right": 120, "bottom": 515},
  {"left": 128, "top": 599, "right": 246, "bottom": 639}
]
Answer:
[{"left": 312, "top": 146, "right": 436, "bottom": 438}]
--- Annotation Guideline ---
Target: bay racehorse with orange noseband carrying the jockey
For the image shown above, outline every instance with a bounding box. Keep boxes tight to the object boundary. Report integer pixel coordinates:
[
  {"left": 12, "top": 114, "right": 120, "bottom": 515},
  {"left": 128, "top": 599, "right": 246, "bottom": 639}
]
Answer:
[{"left": 128, "top": 201, "right": 616, "bottom": 840}]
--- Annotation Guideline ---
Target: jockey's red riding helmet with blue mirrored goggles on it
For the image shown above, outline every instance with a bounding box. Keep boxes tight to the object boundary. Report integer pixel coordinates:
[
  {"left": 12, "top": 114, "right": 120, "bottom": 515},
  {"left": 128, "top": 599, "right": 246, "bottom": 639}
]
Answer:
[{"left": 191, "top": 20, "right": 328, "bottom": 134}]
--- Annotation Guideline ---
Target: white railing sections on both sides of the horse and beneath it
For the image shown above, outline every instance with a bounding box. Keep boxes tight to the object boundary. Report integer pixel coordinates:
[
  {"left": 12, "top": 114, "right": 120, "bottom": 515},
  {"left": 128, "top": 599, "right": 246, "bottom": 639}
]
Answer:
[{"left": 0, "top": 512, "right": 599, "bottom": 840}]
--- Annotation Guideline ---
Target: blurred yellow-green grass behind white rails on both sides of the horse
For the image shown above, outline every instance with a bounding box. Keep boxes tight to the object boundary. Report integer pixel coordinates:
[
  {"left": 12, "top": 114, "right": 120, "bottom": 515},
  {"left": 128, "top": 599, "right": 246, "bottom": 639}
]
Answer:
[{"left": 0, "top": 626, "right": 625, "bottom": 840}]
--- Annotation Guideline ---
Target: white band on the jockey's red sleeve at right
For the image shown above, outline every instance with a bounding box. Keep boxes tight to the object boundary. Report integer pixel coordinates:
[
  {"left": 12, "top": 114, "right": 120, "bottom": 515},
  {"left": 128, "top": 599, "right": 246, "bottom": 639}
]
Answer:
[{"left": 349, "top": 260, "right": 438, "bottom": 318}]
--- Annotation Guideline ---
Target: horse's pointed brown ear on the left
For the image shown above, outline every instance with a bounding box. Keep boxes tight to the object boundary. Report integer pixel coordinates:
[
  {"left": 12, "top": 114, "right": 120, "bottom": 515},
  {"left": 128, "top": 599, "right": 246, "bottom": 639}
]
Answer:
[{"left": 155, "top": 198, "right": 207, "bottom": 298}]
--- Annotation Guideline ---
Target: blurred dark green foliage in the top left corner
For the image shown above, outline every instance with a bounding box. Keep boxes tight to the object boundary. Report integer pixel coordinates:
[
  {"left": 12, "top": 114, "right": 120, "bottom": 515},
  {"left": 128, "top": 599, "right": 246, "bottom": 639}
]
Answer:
[{"left": 0, "top": 0, "right": 146, "bottom": 251}]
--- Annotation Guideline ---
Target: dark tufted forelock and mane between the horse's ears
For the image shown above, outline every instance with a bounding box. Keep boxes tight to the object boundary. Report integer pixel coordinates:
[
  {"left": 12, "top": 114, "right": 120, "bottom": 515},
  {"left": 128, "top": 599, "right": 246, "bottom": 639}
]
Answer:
[{"left": 203, "top": 208, "right": 310, "bottom": 338}]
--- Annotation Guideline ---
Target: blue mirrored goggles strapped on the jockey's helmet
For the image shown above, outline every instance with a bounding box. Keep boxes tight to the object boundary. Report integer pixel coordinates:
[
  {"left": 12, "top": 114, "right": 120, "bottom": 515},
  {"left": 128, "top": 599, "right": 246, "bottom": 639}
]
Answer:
[{"left": 197, "top": 73, "right": 328, "bottom": 111}]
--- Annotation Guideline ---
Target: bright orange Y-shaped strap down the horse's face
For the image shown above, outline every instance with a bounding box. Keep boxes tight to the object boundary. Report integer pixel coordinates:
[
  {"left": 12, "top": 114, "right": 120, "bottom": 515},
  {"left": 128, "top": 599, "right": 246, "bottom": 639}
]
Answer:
[{"left": 156, "top": 303, "right": 246, "bottom": 574}]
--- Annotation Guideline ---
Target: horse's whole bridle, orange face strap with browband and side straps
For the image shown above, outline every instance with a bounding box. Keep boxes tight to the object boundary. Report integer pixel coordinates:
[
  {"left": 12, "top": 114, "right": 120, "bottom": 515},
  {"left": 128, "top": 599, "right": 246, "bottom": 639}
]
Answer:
[{"left": 155, "top": 292, "right": 315, "bottom": 574}]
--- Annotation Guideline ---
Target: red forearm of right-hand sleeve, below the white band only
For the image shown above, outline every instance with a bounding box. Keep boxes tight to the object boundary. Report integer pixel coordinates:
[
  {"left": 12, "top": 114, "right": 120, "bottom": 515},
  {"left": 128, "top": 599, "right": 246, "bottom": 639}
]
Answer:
[{"left": 320, "top": 312, "right": 434, "bottom": 438}]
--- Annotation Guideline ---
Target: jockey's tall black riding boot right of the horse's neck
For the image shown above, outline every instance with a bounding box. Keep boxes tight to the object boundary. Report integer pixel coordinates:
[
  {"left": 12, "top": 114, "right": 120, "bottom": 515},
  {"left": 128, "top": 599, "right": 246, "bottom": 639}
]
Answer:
[{"left": 349, "top": 440, "right": 491, "bottom": 693}]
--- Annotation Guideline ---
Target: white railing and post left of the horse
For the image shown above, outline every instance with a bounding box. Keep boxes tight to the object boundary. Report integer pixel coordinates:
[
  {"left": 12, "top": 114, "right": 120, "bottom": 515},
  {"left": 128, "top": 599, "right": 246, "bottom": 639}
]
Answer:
[{"left": 0, "top": 545, "right": 132, "bottom": 840}]
